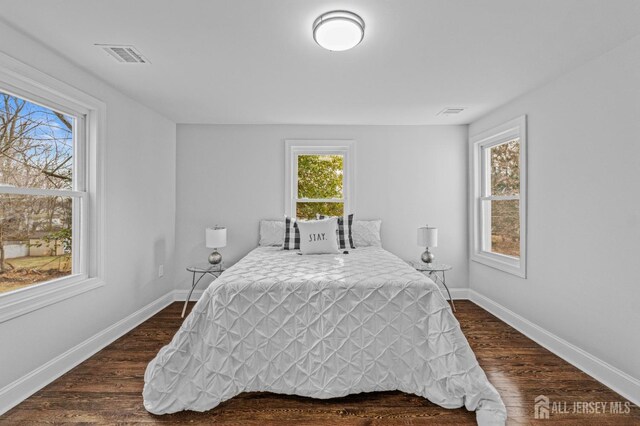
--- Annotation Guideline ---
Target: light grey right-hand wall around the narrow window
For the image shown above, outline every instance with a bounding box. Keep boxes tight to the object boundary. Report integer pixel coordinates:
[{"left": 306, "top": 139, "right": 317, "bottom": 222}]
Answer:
[{"left": 469, "top": 34, "right": 640, "bottom": 378}]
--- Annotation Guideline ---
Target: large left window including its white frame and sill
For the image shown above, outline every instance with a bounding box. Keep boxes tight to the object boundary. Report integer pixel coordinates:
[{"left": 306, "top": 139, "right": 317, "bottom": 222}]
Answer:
[{"left": 0, "top": 53, "right": 105, "bottom": 322}]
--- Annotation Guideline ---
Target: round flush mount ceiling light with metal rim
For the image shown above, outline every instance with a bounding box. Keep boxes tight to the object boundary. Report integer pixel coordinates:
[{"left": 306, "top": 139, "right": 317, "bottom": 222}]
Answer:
[{"left": 313, "top": 10, "right": 364, "bottom": 52}]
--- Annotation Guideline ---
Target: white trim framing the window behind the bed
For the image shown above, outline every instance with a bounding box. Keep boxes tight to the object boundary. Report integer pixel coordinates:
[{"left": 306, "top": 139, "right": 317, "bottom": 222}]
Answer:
[{"left": 284, "top": 139, "right": 355, "bottom": 217}]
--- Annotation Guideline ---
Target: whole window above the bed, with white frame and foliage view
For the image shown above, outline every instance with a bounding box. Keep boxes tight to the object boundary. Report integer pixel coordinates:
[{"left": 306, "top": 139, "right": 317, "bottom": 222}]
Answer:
[{"left": 285, "top": 141, "right": 353, "bottom": 219}]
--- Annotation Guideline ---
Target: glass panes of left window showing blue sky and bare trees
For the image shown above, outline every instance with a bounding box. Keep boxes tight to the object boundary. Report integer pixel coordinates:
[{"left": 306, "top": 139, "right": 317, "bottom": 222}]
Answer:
[{"left": 0, "top": 91, "right": 87, "bottom": 293}]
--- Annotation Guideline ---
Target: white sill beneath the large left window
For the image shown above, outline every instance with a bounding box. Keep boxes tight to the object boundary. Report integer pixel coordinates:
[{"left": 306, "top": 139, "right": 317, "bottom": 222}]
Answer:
[{"left": 0, "top": 275, "right": 104, "bottom": 323}]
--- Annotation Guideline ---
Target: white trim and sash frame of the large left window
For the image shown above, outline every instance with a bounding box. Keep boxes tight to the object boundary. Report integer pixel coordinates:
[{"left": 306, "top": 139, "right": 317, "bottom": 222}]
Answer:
[{"left": 0, "top": 52, "right": 106, "bottom": 323}]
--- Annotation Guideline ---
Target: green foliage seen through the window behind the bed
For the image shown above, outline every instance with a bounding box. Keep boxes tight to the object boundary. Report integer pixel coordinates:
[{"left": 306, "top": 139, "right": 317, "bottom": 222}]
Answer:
[{"left": 296, "top": 155, "right": 344, "bottom": 219}]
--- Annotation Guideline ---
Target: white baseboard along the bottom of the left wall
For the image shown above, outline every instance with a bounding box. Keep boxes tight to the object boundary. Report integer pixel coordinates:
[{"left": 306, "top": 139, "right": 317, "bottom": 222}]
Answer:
[{"left": 0, "top": 291, "right": 175, "bottom": 415}]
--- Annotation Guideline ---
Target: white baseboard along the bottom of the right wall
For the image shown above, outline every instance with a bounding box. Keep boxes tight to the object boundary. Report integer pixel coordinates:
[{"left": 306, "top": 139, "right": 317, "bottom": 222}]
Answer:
[{"left": 468, "top": 289, "right": 640, "bottom": 406}]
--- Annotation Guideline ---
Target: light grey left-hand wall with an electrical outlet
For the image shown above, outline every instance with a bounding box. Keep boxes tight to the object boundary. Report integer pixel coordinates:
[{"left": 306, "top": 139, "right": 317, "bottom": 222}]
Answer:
[{"left": 0, "top": 22, "right": 175, "bottom": 390}]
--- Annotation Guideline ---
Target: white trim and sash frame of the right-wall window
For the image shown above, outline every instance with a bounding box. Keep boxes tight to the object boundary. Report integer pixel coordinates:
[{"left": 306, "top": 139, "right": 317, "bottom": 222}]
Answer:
[{"left": 469, "top": 115, "right": 527, "bottom": 278}]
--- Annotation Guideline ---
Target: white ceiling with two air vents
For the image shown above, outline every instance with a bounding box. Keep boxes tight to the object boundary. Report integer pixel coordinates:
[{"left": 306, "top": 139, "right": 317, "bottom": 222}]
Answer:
[{"left": 0, "top": 0, "right": 640, "bottom": 124}]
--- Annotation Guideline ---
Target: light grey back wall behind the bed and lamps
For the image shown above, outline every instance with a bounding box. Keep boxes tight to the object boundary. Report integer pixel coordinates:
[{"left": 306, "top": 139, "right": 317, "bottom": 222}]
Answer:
[{"left": 176, "top": 125, "right": 468, "bottom": 287}]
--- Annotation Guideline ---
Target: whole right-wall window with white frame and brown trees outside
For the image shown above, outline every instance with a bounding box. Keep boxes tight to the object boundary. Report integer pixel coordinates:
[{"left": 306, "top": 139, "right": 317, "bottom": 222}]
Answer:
[{"left": 471, "top": 116, "right": 526, "bottom": 278}]
